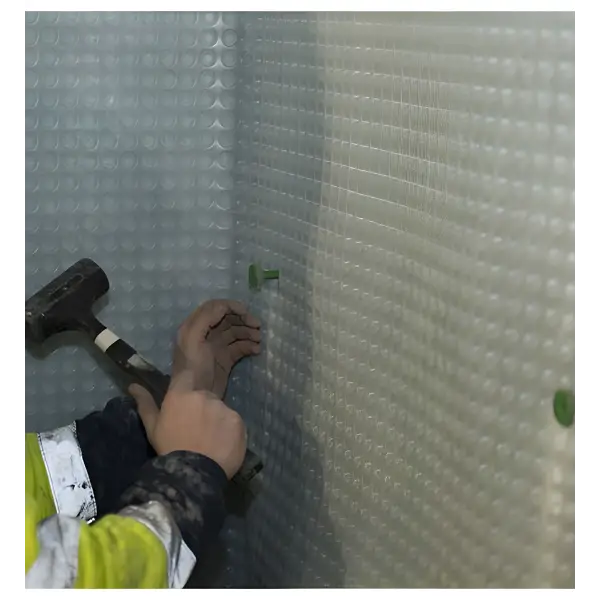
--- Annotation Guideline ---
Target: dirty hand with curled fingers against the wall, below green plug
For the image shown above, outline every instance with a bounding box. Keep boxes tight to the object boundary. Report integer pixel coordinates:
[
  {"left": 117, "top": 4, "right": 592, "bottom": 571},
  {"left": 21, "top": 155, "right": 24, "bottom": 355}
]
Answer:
[{"left": 171, "top": 300, "right": 260, "bottom": 399}]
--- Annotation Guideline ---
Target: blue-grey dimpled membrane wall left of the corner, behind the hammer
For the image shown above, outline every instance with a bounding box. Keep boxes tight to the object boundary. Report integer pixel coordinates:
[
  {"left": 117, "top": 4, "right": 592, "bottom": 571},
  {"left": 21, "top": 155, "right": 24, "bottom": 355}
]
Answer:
[{"left": 24, "top": 13, "right": 237, "bottom": 427}]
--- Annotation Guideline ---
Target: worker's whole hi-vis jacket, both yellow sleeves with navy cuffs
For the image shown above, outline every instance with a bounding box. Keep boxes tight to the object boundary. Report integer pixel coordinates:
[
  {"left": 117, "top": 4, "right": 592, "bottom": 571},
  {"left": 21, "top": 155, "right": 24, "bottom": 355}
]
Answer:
[{"left": 24, "top": 400, "right": 227, "bottom": 588}]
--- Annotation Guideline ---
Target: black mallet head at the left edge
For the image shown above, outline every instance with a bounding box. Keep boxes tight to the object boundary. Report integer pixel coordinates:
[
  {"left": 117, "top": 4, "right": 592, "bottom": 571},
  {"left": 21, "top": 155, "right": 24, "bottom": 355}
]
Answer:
[{"left": 23, "top": 258, "right": 109, "bottom": 344}]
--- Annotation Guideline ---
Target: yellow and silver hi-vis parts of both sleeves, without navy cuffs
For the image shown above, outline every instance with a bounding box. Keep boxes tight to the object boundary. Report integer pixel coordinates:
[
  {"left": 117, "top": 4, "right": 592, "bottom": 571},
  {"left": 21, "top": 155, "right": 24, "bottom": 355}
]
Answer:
[{"left": 24, "top": 427, "right": 195, "bottom": 589}]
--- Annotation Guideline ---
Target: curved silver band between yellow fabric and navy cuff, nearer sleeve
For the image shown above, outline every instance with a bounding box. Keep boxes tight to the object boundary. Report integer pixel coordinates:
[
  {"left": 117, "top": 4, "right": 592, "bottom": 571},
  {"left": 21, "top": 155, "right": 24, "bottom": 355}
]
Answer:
[{"left": 119, "top": 502, "right": 196, "bottom": 589}]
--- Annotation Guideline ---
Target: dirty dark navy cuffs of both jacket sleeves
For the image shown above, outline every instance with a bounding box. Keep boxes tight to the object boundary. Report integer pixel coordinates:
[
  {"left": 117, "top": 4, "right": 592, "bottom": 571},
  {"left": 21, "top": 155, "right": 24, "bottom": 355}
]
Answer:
[{"left": 75, "top": 398, "right": 228, "bottom": 560}]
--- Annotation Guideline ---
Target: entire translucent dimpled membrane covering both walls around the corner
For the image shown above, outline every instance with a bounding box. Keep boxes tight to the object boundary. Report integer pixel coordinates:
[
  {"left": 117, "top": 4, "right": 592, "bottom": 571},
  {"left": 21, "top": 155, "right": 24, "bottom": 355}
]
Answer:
[{"left": 25, "top": 13, "right": 576, "bottom": 587}]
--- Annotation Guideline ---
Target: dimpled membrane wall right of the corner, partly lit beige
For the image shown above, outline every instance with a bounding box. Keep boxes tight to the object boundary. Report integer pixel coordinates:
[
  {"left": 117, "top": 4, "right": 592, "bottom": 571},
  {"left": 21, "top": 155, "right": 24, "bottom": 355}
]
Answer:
[{"left": 234, "top": 13, "right": 576, "bottom": 587}]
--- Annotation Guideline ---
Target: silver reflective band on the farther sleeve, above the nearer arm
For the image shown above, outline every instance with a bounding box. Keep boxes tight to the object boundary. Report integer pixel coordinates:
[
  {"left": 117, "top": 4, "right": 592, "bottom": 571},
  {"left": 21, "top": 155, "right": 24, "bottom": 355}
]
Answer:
[{"left": 38, "top": 423, "right": 96, "bottom": 520}]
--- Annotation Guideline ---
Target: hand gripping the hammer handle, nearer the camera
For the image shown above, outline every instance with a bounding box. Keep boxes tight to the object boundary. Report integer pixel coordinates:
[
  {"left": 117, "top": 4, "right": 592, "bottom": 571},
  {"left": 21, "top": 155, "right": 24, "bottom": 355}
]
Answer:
[{"left": 129, "top": 384, "right": 246, "bottom": 479}]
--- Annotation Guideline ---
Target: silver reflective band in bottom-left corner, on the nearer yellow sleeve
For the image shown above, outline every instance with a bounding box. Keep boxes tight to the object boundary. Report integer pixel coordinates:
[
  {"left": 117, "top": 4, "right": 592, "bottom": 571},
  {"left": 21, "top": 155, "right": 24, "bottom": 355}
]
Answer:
[{"left": 25, "top": 515, "right": 81, "bottom": 589}]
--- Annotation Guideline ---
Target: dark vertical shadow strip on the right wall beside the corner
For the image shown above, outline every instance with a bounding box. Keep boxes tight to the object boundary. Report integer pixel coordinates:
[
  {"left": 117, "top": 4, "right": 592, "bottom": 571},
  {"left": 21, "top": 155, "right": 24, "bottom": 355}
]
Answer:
[{"left": 190, "top": 13, "right": 345, "bottom": 588}]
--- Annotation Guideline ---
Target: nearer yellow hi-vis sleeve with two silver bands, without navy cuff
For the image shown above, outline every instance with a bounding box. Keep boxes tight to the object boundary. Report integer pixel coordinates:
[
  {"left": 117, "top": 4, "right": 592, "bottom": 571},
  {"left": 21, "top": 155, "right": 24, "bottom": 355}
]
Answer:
[{"left": 24, "top": 497, "right": 190, "bottom": 589}]
